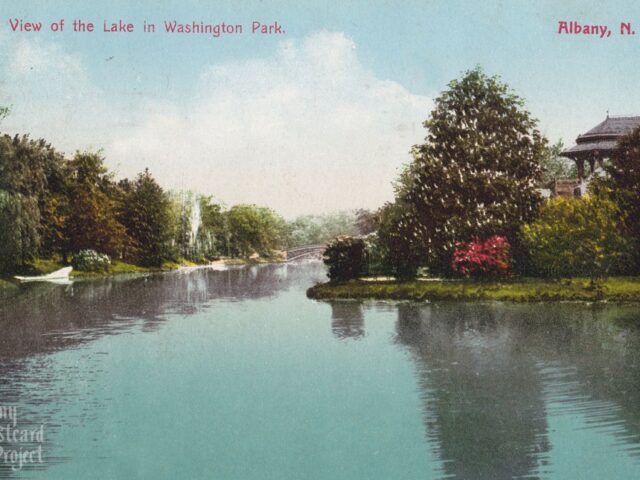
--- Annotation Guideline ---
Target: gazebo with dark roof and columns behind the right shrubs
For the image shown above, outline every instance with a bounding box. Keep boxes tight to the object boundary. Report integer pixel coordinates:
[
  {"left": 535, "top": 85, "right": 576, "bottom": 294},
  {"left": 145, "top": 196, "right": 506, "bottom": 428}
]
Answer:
[{"left": 560, "top": 114, "right": 640, "bottom": 182}]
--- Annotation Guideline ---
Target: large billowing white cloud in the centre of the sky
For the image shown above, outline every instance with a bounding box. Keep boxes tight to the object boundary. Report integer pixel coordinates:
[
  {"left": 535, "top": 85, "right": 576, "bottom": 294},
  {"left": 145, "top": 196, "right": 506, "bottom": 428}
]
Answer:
[{"left": 108, "top": 32, "right": 431, "bottom": 215}]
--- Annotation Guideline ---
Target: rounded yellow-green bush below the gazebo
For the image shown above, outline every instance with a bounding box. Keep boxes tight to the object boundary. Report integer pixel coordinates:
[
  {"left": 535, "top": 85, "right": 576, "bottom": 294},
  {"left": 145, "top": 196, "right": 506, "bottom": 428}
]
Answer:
[{"left": 522, "top": 195, "right": 632, "bottom": 278}]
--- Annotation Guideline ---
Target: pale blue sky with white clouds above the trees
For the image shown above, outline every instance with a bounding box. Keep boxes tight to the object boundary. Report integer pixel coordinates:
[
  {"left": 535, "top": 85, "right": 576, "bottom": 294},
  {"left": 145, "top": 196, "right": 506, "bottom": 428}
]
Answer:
[{"left": 0, "top": 0, "right": 640, "bottom": 218}]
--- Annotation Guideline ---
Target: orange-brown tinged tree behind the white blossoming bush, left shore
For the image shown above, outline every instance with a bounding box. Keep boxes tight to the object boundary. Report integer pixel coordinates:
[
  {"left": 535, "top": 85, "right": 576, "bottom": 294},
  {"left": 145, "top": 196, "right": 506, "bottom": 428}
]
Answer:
[{"left": 64, "top": 152, "right": 127, "bottom": 258}]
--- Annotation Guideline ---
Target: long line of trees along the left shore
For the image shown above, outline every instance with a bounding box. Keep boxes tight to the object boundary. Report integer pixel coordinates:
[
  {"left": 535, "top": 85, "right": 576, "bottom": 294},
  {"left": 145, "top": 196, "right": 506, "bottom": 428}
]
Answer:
[{"left": 0, "top": 131, "right": 368, "bottom": 273}]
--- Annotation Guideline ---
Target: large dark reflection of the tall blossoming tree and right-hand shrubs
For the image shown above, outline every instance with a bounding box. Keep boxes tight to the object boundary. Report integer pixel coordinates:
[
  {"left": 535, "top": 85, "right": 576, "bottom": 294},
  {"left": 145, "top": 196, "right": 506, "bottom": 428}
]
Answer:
[{"left": 396, "top": 303, "right": 640, "bottom": 479}]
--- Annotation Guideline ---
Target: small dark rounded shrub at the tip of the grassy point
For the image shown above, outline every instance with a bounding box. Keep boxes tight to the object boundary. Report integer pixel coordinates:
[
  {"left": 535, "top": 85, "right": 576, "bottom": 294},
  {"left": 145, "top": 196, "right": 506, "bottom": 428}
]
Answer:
[{"left": 323, "top": 236, "right": 365, "bottom": 281}]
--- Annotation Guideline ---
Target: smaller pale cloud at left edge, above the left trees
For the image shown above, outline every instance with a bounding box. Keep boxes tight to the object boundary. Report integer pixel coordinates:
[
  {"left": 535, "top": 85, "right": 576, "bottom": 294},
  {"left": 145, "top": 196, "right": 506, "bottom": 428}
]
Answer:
[{"left": 0, "top": 37, "right": 119, "bottom": 154}]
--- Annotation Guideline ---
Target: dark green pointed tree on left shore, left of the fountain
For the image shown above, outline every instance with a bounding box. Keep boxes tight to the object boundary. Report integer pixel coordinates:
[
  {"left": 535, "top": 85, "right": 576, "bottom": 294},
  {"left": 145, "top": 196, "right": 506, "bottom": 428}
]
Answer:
[{"left": 121, "top": 169, "right": 172, "bottom": 267}]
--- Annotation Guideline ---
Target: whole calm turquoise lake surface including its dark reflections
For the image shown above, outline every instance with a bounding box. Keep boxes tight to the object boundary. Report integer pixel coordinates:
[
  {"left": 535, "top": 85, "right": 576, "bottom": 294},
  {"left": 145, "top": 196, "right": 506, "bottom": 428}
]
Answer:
[{"left": 0, "top": 263, "right": 640, "bottom": 480}]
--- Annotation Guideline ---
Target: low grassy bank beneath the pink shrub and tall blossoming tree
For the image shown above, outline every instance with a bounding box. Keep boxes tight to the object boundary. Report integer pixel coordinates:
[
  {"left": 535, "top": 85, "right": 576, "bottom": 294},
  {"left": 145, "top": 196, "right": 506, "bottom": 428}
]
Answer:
[{"left": 307, "top": 277, "right": 640, "bottom": 302}]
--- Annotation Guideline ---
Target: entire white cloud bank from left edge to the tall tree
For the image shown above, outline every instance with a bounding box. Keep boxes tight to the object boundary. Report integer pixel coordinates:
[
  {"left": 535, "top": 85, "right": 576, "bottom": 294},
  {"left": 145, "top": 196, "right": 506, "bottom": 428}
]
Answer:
[{"left": 0, "top": 32, "right": 431, "bottom": 216}]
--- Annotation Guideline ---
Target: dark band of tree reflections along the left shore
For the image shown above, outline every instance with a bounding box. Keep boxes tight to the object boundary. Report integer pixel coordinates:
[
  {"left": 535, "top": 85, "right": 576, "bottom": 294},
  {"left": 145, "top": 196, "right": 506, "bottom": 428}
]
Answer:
[{"left": 0, "top": 264, "right": 324, "bottom": 362}]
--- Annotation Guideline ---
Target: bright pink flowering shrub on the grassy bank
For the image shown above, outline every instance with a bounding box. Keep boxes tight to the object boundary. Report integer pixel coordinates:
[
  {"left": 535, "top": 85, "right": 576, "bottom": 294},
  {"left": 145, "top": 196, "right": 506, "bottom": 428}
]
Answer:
[{"left": 451, "top": 235, "right": 511, "bottom": 277}]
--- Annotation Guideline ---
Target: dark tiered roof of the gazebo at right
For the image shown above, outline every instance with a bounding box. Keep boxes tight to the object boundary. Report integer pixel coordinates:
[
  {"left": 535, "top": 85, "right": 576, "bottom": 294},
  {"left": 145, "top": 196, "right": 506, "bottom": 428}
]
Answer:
[{"left": 561, "top": 116, "right": 640, "bottom": 157}]
